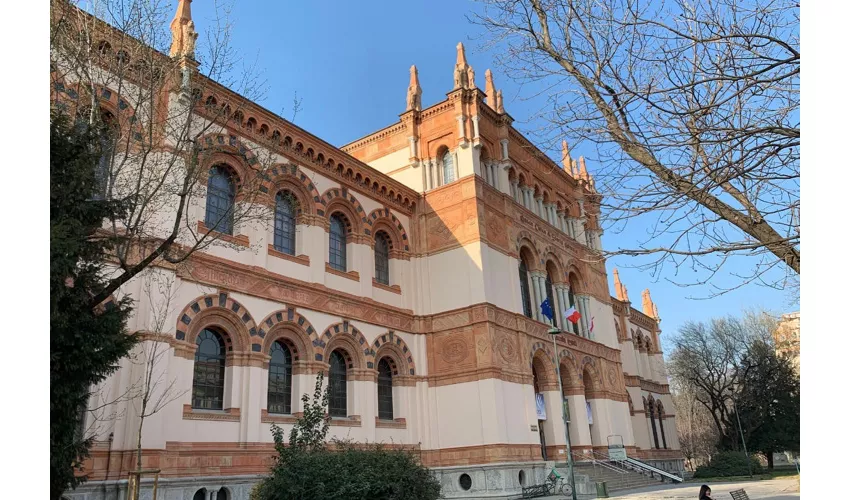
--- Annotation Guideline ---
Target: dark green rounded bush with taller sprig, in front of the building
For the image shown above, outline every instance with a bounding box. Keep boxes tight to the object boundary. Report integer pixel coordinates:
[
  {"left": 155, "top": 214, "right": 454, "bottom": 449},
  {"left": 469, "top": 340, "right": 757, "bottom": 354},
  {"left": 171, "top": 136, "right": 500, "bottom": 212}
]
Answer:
[{"left": 251, "top": 375, "right": 440, "bottom": 500}]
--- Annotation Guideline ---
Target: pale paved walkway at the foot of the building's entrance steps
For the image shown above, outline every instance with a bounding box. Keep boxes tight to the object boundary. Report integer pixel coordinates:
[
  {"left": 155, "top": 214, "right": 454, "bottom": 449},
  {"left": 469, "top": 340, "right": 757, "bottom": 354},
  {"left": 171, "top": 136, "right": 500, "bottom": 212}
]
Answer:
[{"left": 545, "top": 478, "right": 800, "bottom": 500}]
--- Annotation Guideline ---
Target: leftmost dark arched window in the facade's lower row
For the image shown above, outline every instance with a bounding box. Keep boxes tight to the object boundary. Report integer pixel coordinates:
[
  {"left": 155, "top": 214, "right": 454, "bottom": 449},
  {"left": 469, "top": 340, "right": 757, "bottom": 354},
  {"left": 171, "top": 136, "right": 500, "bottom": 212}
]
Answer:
[{"left": 192, "top": 329, "right": 224, "bottom": 410}]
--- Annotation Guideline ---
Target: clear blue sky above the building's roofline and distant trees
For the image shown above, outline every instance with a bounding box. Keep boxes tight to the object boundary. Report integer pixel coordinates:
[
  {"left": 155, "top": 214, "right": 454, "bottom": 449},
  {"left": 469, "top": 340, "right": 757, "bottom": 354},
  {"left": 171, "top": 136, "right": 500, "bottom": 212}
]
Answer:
[{"left": 184, "top": 0, "right": 799, "bottom": 342}]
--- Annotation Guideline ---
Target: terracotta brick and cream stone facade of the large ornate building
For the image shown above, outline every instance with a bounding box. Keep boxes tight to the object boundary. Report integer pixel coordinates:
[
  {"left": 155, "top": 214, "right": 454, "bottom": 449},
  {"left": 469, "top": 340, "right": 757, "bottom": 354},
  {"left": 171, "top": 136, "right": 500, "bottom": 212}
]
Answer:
[{"left": 52, "top": 0, "right": 682, "bottom": 500}]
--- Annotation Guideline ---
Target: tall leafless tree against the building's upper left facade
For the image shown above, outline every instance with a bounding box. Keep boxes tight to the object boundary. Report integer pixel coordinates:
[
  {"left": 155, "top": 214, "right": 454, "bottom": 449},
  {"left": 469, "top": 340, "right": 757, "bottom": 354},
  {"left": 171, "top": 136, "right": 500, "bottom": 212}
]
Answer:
[{"left": 51, "top": 0, "right": 278, "bottom": 306}]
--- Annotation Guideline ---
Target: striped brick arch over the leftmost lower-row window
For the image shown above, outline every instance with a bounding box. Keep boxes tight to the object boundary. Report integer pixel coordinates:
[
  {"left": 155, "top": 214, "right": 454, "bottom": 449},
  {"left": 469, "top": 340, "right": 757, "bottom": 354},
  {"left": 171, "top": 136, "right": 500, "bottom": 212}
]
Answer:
[{"left": 175, "top": 292, "right": 262, "bottom": 352}]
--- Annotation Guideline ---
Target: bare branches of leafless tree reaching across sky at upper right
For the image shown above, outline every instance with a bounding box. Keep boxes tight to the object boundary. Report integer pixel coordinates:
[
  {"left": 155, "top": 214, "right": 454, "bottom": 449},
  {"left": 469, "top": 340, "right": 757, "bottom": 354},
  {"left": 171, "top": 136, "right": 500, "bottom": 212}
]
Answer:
[{"left": 472, "top": 0, "right": 800, "bottom": 293}]
